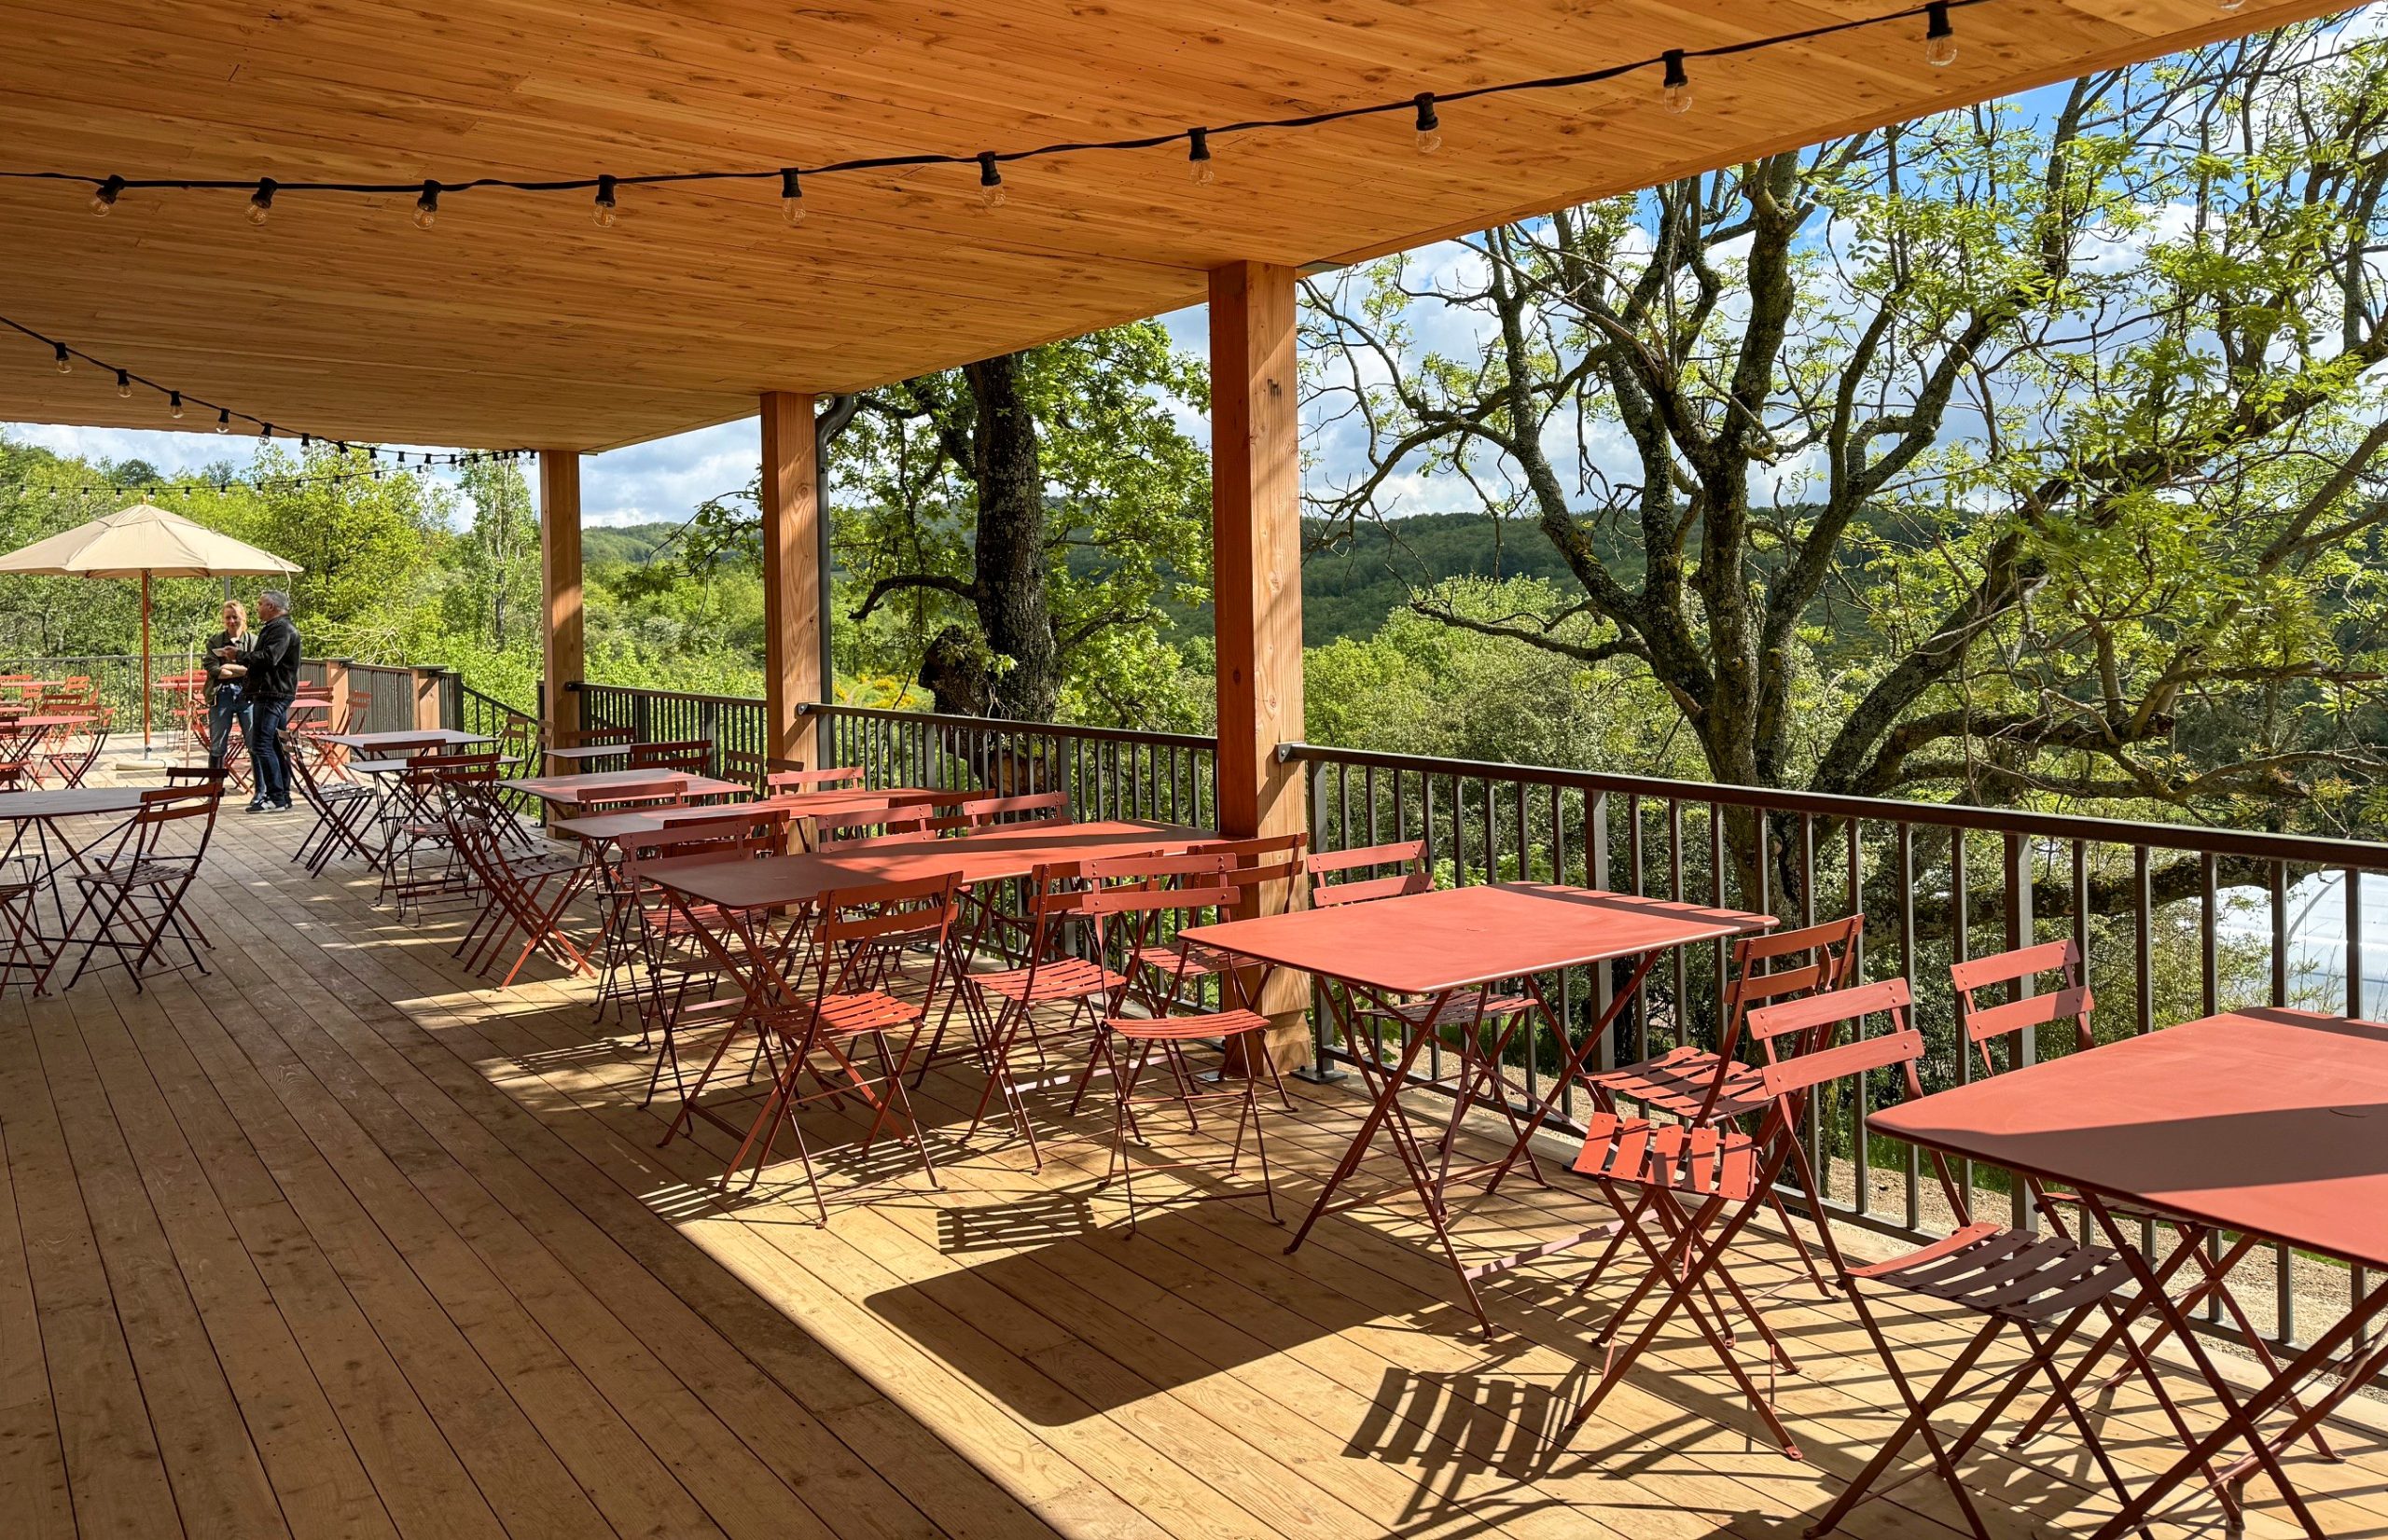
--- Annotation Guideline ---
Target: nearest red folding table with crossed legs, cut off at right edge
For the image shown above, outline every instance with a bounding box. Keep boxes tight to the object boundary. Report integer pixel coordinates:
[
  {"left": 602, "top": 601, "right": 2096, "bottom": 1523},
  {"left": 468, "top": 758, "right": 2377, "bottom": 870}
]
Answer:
[{"left": 1843, "top": 1007, "right": 2388, "bottom": 1540}]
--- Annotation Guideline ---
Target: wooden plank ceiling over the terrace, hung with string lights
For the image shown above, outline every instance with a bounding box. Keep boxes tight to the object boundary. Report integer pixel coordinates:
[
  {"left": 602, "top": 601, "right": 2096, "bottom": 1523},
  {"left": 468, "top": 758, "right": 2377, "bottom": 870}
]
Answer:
[{"left": 0, "top": 0, "right": 2331, "bottom": 449}]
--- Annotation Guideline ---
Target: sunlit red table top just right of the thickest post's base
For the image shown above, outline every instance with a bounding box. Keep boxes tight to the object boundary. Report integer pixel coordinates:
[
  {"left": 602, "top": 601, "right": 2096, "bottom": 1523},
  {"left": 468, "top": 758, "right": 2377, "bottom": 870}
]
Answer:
[{"left": 1185, "top": 883, "right": 1777, "bottom": 995}]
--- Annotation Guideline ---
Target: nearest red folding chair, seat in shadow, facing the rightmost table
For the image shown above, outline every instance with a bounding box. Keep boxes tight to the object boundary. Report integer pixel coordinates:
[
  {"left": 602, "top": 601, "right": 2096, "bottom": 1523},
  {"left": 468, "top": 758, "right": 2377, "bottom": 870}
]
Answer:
[{"left": 1785, "top": 974, "right": 2238, "bottom": 1540}]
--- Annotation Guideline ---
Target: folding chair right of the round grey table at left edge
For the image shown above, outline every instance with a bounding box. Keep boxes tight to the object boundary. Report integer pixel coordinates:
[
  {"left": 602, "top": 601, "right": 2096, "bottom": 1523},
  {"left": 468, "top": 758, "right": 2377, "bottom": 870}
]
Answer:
[{"left": 67, "top": 776, "right": 225, "bottom": 993}]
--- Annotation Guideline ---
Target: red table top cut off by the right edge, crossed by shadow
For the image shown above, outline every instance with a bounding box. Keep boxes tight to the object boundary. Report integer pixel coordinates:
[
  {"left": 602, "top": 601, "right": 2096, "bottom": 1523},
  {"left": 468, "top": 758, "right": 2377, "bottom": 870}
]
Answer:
[{"left": 1869, "top": 1007, "right": 2388, "bottom": 1268}]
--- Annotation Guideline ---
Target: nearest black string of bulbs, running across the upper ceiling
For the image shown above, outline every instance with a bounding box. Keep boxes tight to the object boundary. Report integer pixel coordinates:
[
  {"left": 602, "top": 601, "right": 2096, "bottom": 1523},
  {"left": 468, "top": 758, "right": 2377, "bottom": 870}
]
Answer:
[{"left": 0, "top": 0, "right": 2015, "bottom": 227}]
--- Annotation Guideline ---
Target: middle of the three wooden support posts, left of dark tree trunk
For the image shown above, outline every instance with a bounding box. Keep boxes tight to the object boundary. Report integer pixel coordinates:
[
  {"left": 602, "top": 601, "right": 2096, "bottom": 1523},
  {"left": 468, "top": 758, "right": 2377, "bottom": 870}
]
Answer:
[{"left": 762, "top": 392, "right": 828, "bottom": 764}]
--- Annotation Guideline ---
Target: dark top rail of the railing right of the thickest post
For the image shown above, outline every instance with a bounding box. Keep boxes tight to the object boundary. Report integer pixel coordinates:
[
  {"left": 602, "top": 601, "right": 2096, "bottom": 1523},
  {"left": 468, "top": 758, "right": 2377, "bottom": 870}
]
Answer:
[{"left": 1278, "top": 742, "right": 2388, "bottom": 871}]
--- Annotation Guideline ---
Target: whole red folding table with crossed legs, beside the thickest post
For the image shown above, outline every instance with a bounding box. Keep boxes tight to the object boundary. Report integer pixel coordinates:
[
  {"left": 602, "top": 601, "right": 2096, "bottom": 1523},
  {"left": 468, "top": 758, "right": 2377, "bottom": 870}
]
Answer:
[{"left": 1185, "top": 883, "right": 1774, "bottom": 1332}]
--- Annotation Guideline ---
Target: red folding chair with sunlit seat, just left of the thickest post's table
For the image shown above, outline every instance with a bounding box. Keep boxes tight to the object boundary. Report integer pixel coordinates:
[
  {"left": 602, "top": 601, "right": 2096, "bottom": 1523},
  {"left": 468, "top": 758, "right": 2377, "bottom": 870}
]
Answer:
[{"left": 1056, "top": 850, "right": 1284, "bottom": 1232}]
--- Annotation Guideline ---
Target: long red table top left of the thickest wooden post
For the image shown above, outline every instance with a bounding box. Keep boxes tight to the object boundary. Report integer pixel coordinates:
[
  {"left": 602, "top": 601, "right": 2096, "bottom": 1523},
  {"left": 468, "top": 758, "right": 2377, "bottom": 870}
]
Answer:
[{"left": 657, "top": 819, "right": 1218, "bottom": 909}]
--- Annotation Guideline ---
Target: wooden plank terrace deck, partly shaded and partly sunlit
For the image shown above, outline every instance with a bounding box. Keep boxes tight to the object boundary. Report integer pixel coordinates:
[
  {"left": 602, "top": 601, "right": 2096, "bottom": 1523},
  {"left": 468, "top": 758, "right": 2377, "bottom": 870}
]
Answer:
[{"left": 0, "top": 792, "right": 2388, "bottom": 1540}]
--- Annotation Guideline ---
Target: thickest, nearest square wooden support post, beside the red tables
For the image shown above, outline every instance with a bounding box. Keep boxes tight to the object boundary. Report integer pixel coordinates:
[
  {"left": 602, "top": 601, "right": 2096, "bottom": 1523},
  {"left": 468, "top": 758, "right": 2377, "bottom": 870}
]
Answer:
[{"left": 1211, "top": 263, "right": 1311, "bottom": 1070}]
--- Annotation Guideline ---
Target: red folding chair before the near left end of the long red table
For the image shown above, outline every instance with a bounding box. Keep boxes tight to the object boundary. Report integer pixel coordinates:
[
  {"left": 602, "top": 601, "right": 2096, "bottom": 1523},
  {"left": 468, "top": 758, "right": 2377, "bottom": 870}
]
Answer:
[{"left": 698, "top": 871, "right": 958, "bottom": 1225}]
